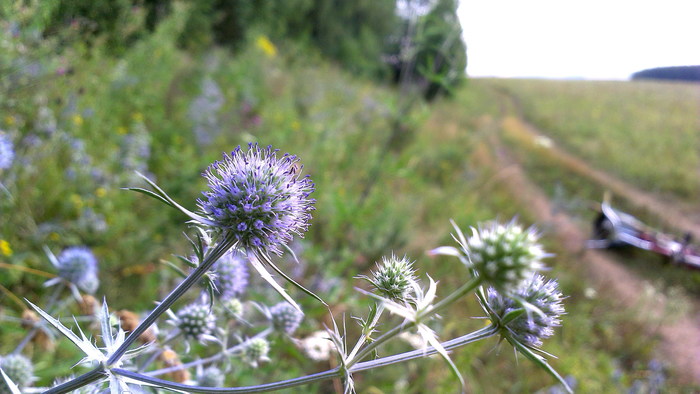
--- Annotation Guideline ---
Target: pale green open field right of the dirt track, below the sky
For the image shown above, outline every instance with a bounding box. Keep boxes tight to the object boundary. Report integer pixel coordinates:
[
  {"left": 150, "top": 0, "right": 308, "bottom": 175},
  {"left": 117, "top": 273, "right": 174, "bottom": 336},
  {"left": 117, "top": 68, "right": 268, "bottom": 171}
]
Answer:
[{"left": 492, "top": 80, "right": 700, "bottom": 202}]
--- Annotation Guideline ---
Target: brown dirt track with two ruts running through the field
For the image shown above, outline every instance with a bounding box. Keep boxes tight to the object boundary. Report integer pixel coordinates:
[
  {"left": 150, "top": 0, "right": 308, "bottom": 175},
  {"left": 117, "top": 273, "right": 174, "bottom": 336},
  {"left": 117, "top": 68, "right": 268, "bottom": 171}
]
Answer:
[{"left": 474, "top": 90, "right": 700, "bottom": 384}]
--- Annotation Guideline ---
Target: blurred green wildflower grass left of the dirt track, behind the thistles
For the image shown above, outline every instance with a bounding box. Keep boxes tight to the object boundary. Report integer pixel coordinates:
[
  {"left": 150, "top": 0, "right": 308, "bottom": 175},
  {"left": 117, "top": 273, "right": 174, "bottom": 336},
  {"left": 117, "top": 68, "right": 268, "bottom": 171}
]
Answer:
[{"left": 0, "top": 3, "right": 696, "bottom": 393}]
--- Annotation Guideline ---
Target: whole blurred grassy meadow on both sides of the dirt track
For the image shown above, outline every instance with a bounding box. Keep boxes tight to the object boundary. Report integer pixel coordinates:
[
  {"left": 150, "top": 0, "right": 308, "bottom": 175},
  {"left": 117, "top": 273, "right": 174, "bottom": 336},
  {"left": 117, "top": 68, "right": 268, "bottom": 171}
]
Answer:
[{"left": 0, "top": 3, "right": 700, "bottom": 393}]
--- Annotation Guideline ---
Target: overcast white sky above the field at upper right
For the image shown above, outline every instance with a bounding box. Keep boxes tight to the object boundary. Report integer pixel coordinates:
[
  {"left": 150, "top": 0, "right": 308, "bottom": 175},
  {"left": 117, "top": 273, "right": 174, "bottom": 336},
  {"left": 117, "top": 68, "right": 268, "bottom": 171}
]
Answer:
[{"left": 458, "top": 0, "right": 700, "bottom": 79}]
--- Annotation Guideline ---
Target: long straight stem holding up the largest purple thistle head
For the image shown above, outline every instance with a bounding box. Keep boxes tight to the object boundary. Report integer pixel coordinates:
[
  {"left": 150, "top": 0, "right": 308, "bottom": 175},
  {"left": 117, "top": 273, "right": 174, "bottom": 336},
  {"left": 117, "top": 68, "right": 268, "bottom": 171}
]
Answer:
[{"left": 107, "top": 235, "right": 236, "bottom": 366}]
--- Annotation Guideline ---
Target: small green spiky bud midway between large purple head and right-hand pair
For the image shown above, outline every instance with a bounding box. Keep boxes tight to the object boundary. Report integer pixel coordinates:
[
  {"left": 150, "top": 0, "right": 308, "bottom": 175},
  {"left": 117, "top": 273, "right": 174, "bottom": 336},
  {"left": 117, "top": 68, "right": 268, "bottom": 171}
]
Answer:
[{"left": 362, "top": 254, "right": 416, "bottom": 301}]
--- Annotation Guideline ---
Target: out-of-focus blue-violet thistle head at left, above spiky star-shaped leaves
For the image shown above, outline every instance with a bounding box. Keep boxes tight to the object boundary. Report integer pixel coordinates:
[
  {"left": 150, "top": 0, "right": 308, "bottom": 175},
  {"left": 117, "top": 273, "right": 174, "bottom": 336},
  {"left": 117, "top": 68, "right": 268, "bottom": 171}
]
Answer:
[{"left": 56, "top": 246, "right": 99, "bottom": 294}]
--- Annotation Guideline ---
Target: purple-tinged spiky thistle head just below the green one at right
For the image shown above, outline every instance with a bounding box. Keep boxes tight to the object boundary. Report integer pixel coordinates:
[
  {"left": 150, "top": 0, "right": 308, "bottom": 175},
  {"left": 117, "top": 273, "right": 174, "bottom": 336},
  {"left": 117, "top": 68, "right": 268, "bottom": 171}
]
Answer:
[{"left": 486, "top": 275, "right": 565, "bottom": 347}]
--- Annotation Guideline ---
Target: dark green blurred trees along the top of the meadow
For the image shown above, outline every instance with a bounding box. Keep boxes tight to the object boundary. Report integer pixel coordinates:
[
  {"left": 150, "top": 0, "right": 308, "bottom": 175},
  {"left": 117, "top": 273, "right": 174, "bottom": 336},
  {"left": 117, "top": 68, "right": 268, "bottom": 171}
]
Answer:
[{"left": 46, "top": 0, "right": 467, "bottom": 99}]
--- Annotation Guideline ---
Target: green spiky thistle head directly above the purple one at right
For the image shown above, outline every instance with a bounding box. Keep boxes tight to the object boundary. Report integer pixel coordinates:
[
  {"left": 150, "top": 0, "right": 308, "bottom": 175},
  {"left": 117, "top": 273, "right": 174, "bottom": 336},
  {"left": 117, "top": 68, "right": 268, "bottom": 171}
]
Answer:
[{"left": 462, "top": 222, "right": 548, "bottom": 292}]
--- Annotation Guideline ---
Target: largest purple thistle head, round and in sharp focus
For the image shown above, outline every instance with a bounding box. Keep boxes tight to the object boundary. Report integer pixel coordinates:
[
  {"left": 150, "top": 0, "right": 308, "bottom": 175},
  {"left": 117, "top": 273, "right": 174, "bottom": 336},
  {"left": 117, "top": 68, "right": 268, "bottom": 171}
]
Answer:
[{"left": 197, "top": 144, "right": 316, "bottom": 255}]
